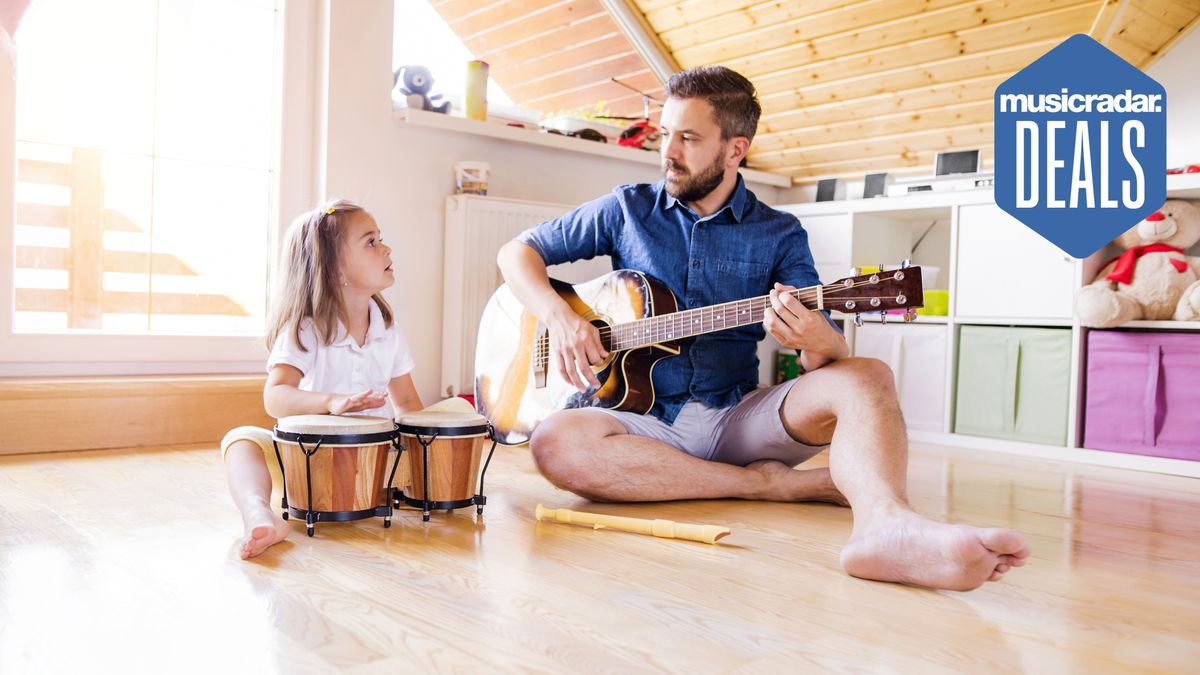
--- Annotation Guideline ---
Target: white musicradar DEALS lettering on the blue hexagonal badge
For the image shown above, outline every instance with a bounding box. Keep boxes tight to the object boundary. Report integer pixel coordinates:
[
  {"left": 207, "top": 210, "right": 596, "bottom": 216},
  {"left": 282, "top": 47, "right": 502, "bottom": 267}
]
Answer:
[{"left": 1000, "top": 86, "right": 1163, "bottom": 209}]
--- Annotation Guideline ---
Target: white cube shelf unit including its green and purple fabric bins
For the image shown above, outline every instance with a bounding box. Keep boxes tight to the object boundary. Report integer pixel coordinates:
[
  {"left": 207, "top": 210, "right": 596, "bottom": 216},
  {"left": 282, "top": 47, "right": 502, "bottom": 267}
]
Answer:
[{"left": 780, "top": 178, "right": 1200, "bottom": 477}]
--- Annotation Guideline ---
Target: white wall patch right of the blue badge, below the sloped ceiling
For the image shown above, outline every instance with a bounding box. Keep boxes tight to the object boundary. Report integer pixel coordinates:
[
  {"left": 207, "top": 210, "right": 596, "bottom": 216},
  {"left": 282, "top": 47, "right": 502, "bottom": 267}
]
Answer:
[{"left": 1146, "top": 29, "right": 1200, "bottom": 168}]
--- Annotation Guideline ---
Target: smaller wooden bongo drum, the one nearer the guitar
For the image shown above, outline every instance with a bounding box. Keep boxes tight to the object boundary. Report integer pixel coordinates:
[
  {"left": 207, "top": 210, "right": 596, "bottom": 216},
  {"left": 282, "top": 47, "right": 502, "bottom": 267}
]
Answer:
[{"left": 397, "top": 410, "right": 496, "bottom": 520}]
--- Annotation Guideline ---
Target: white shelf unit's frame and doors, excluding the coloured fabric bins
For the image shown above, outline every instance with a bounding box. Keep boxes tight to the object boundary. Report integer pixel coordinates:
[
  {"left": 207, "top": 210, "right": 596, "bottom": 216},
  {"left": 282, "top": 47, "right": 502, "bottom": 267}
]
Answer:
[{"left": 779, "top": 174, "right": 1200, "bottom": 477}]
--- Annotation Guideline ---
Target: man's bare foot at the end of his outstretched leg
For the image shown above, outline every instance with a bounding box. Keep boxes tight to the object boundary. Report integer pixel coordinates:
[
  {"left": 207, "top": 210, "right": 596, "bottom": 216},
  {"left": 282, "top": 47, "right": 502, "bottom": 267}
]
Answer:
[{"left": 841, "top": 510, "right": 1030, "bottom": 591}]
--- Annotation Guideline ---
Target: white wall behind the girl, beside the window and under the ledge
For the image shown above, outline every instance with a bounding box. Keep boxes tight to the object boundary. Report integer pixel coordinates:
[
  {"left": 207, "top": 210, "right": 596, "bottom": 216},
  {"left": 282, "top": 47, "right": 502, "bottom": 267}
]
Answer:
[{"left": 320, "top": 0, "right": 779, "bottom": 401}]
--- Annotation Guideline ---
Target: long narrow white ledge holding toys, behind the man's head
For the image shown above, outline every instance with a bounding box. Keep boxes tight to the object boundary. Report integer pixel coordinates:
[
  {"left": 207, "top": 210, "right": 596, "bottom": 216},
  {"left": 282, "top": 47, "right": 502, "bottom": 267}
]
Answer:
[{"left": 392, "top": 108, "right": 792, "bottom": 187}]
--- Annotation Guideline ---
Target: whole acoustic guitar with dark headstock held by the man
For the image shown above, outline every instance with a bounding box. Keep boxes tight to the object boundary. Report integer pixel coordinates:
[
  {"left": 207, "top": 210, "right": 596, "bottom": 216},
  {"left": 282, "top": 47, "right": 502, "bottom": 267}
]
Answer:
[{"left": 475, "top": 267, "right": 922, "bottom": 446}]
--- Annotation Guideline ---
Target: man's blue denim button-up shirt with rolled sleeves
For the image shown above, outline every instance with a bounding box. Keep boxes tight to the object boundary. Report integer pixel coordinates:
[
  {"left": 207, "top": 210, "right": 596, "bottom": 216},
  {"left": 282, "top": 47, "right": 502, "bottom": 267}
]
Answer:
[{"left": 517, "top": 175, "right": 828, "bottom": 424}]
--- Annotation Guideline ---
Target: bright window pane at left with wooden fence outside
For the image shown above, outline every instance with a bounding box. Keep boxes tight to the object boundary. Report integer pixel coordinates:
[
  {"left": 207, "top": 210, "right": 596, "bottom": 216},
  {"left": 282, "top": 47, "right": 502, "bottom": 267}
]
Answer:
[{"left": 12, "top": 0, "right": 280, "bottom": 335}]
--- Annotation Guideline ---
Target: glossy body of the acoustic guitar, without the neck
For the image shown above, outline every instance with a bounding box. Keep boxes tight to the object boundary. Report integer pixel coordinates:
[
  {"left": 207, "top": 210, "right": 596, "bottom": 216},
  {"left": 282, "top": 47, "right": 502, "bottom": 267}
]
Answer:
[{"left": 475, "top": 270, "right": 679, "bottom": 446}]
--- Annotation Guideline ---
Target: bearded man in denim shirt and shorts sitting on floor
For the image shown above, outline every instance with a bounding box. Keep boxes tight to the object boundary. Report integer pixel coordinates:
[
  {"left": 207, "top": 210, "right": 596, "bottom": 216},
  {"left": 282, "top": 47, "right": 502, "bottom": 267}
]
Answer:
[{"left": 498, "top": 66, "right": 1028, "bottom": 590}]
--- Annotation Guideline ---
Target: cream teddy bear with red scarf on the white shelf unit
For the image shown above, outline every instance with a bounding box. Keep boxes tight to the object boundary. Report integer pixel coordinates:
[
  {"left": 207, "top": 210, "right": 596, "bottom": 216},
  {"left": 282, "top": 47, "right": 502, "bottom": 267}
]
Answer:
[{"left": 1075, "top": 199, "right": 1200, "bottom": 328}]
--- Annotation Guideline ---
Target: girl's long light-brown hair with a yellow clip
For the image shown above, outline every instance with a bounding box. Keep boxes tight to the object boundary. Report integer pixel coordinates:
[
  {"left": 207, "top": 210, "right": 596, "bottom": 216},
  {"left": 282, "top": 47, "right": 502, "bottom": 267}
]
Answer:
[{"left": 266, "top": 199, "right": 392, "bottom": 351}]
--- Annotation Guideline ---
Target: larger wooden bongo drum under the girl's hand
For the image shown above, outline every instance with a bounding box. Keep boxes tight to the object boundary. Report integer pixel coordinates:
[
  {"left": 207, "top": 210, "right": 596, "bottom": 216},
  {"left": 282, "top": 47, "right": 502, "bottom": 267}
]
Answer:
[{"left": 275, "top": 414, "right": 400, "bottom": 537}]
